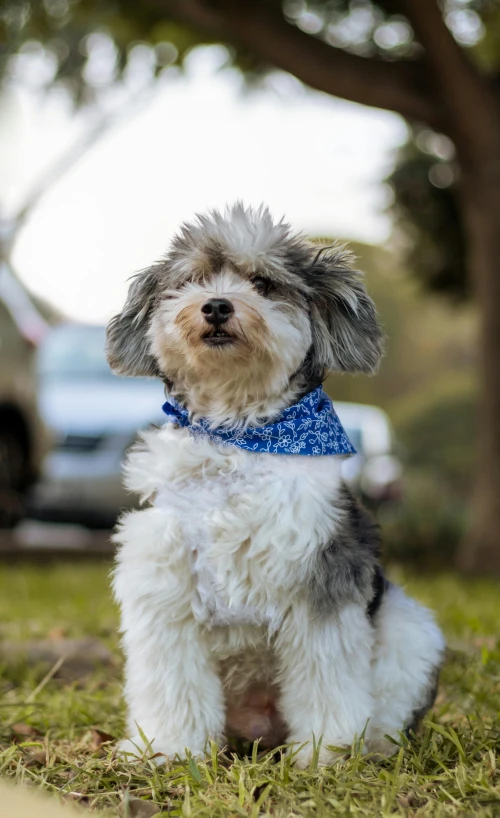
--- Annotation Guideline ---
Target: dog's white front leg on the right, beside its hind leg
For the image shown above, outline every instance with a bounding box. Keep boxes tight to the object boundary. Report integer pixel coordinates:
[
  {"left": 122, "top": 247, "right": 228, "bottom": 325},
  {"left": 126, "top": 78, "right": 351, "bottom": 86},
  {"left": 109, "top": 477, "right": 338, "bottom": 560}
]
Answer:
[{"left": 276, "top": 602, "right": 373, "bottom": 767}]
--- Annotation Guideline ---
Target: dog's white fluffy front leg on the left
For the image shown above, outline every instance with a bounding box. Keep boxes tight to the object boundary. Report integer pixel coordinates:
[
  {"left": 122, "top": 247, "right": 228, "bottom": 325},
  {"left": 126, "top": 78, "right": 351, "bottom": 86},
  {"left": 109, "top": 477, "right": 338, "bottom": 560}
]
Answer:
[{"left": 114, "top": 509, "right": 225, "bottom": 764}]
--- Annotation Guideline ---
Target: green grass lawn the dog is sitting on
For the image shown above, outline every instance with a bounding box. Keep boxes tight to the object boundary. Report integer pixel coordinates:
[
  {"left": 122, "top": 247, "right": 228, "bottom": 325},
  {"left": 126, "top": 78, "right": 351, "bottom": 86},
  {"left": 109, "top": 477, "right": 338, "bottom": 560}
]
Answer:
[{"left": 0, "top": 564, "right": 500, "bottom": 818}]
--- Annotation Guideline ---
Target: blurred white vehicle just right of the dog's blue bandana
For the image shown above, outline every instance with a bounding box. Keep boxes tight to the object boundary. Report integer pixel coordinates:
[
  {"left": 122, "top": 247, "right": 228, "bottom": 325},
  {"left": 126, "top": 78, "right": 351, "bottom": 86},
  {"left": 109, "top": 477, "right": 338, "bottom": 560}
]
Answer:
[{"left": 335, "top": 402, "right": 402, "bottom": 506}]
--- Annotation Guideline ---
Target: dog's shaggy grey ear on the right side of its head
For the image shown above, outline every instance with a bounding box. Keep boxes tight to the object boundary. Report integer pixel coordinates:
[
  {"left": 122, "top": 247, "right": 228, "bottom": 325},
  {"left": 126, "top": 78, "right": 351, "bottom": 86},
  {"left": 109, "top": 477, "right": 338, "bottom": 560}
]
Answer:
[{"left": 307, "top": 247, "right": 384, "bottom": 373}]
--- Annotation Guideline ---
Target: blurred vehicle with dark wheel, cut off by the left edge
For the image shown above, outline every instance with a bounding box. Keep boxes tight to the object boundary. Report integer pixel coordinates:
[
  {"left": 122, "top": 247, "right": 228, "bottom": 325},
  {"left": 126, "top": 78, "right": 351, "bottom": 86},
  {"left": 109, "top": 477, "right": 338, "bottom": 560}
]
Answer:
[{"left": 0, "top": 264, "right": 48, "bottom": 528}]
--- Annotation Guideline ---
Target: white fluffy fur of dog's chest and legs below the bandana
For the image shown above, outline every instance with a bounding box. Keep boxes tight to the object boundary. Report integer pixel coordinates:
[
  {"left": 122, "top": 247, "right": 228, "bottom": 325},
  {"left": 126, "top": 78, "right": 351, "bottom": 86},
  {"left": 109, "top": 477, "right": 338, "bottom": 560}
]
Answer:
[{"left": 114, "top": 424, "right": 443, "bottom": 765}]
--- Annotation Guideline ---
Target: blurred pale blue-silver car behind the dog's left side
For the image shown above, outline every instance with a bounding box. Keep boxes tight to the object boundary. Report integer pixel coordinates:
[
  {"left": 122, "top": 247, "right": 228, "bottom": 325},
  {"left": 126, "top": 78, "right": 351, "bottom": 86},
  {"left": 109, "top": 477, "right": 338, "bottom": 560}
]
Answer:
[{"left": 29, "top": 324, "right": 165, "bottom": 528}]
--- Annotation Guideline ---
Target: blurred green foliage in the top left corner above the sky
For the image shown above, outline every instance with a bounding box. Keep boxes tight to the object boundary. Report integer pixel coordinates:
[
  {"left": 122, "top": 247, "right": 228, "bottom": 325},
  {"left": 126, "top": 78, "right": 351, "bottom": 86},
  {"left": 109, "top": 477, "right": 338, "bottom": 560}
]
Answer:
[{"left": 0, "top": 0, "right": 209, "bottom": 104}]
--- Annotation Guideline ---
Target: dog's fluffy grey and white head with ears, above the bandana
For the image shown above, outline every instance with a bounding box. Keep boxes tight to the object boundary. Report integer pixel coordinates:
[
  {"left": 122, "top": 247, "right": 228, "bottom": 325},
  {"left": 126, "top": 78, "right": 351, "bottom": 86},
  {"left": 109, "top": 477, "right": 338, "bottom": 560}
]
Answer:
[{"left": 108, "top": 204, "right": 382, "bottom": 418}]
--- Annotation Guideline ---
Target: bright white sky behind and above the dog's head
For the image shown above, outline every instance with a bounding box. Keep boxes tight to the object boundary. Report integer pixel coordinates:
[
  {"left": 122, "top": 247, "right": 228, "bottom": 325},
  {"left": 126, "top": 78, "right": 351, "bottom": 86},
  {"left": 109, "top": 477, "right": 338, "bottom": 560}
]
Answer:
[{"left": 0, "top": 48, "right": 406, "bottom": 322}]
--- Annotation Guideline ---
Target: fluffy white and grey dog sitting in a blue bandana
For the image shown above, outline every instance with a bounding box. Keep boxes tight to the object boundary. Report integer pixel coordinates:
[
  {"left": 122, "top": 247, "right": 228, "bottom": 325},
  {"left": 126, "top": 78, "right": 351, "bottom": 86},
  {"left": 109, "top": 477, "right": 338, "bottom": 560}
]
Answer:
[{"left": 107, "top": 203, "right": 444, "bottom": 767}]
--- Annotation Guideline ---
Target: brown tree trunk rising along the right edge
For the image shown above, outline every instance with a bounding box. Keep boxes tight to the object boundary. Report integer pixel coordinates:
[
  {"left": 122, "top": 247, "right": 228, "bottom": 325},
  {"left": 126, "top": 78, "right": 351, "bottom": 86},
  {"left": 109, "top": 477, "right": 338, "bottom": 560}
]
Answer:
[{"left": 394, "top": 0, "right": 500, "bottom": 577}]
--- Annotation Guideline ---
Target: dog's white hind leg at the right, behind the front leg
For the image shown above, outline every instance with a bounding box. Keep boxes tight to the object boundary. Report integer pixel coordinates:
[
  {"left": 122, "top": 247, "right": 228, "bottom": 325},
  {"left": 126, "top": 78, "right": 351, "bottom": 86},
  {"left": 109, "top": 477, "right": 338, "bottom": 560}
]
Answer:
[{"left": 366, "top": 584, "right": 445, "bottom": 755}]
